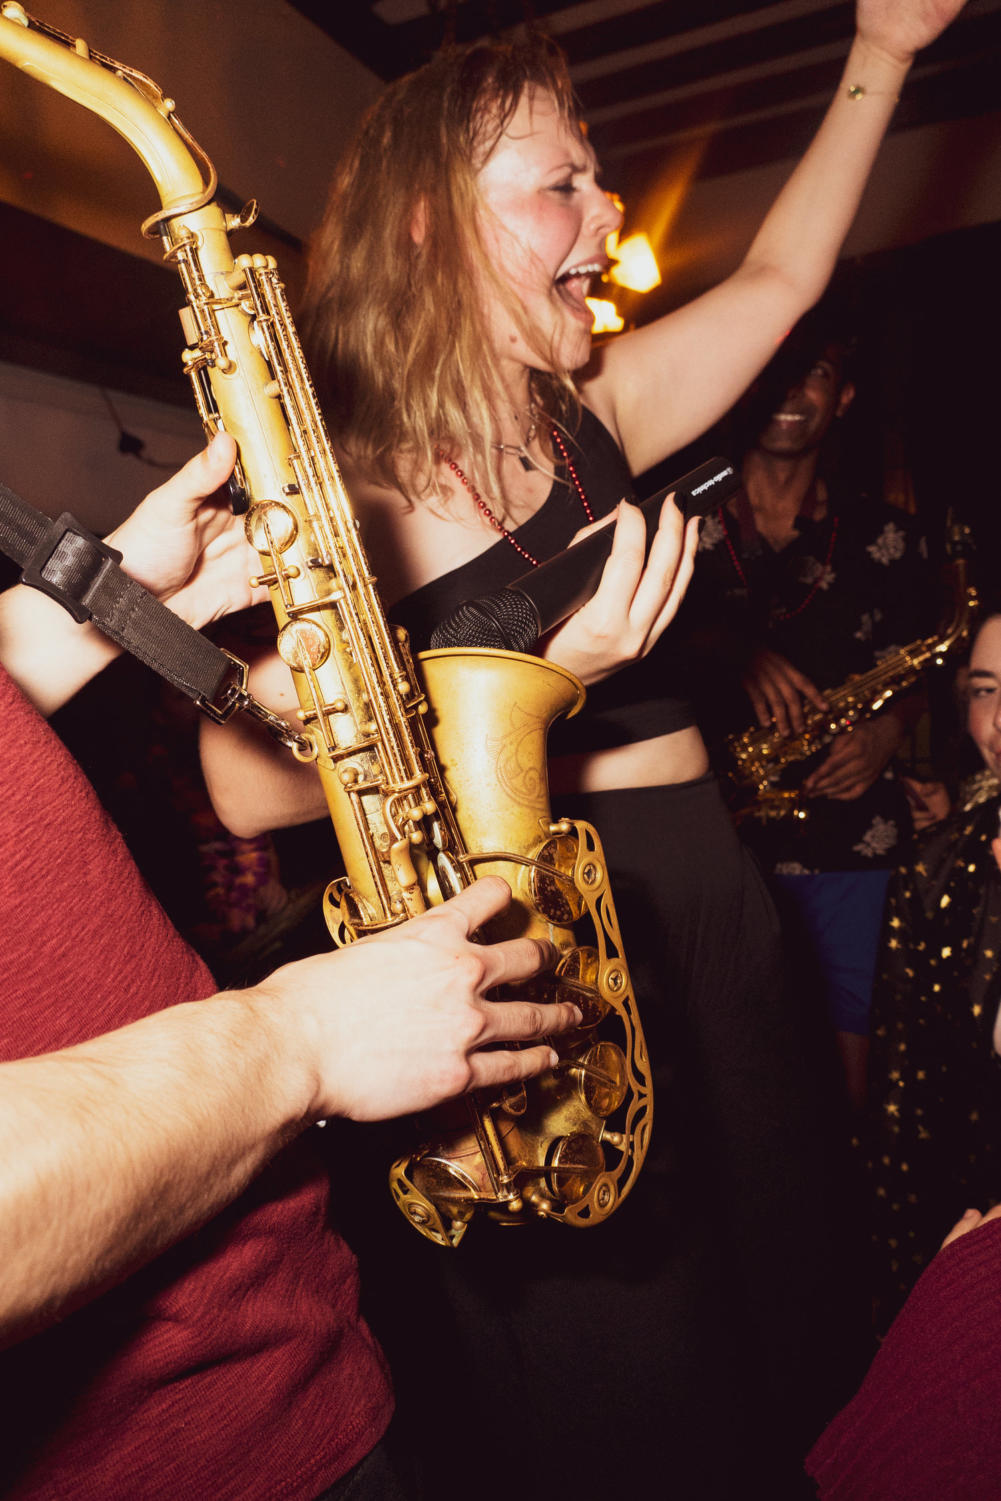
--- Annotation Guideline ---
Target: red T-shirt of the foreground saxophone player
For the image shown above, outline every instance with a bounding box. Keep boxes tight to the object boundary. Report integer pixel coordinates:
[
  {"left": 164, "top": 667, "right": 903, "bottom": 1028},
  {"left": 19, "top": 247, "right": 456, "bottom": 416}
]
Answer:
[{"left": 0, "top": 671, "right": 392, "bottom": 1501}]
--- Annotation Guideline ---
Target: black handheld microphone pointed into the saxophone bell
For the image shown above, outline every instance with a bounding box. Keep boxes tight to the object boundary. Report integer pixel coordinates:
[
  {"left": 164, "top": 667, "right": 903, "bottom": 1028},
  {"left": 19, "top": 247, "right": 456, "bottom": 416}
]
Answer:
[{"left": 431, "top": 459, "right": 741, "bottom": 651}]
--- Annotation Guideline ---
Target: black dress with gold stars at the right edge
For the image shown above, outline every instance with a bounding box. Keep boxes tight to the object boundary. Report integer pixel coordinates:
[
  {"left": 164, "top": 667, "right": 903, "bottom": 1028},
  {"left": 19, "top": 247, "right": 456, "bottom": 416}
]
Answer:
[{"left": 866, "top": 775, "right": 1001, "bottom": 1328}]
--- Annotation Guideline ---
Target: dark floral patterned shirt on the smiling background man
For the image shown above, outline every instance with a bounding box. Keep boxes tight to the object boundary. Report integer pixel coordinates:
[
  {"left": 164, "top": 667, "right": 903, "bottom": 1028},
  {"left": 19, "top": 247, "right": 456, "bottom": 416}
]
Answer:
[{"left": 686, "top": 492, "right": 935, "bottom": 875}]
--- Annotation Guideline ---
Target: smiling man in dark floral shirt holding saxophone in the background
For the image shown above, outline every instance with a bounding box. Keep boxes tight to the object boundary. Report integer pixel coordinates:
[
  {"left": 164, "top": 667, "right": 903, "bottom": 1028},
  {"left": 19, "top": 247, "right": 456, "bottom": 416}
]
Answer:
[{"left": 692, "top": 314, "right": 932, "bottom": 1103}]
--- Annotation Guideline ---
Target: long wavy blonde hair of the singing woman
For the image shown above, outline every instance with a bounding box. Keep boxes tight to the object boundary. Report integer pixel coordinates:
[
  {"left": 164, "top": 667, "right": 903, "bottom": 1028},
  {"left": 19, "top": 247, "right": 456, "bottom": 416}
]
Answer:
[{"left": 303, "top": 36, "right": 579, "bottom": 498}]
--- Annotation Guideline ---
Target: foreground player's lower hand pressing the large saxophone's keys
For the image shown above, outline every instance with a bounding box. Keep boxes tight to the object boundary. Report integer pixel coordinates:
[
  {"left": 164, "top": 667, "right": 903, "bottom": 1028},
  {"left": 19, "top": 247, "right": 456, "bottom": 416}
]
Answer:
[{"left": 257, "top": 877, "right": 581, "bottom": 1121}]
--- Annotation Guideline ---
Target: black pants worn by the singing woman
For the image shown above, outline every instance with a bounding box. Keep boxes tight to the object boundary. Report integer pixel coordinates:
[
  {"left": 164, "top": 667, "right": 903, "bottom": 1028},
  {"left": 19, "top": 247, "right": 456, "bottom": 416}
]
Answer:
[{"left": 327, "top": 778, "right": 854, "bottom": 1501}]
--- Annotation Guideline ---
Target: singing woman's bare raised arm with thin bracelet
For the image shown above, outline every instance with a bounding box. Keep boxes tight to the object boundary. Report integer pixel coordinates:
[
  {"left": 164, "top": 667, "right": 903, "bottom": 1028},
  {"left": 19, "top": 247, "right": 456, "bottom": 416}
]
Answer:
[{"left": 582, "top": 0, "right": 965, "bottom": 473}]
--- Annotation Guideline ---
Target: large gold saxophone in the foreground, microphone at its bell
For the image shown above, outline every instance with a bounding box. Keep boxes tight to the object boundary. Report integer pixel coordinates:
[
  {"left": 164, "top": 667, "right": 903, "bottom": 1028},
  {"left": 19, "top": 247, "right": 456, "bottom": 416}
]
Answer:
[{"left": 0, "top": 0, "right": 653, "bottom": 1246}]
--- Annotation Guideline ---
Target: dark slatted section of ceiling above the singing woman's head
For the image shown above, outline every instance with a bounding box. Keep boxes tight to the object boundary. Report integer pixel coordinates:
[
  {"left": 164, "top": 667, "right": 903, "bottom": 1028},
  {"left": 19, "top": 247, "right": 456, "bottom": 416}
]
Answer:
[{"left": 291, "top": 0, "right": 1001, "bottom": 211}]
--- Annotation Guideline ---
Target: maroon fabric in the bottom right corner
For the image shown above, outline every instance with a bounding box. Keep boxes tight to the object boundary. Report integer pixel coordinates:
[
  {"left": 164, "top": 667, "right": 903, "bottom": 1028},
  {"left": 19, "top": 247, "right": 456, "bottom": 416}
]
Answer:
[{"left": 806, "top": 1220, "right": 1001, "bottom": 1501}]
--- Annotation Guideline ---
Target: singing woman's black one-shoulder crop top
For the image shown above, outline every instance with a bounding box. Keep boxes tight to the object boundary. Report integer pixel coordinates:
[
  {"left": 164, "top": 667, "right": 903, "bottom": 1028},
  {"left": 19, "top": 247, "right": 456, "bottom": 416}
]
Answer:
[{"left": 389, "top": 408, "right": 695, "bottom": 755}]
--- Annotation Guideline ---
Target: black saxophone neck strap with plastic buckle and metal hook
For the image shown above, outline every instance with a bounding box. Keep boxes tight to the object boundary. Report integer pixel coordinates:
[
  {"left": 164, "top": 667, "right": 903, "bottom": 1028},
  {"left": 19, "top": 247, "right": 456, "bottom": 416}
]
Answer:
[{"left": 0, "top": 483, "right": 302, "bottom": 744}]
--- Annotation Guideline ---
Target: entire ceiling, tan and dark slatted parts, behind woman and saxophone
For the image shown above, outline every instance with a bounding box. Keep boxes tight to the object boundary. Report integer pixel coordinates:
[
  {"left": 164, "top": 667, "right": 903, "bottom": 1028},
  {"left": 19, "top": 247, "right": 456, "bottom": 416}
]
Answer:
[{"left": 0, "top": 0, "right": 1001, "bottom": 404}]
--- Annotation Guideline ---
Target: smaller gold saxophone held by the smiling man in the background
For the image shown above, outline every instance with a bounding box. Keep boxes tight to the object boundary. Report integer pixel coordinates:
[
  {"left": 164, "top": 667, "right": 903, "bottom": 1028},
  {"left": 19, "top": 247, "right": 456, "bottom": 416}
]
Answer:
[{"left": 726, "top": 522, "right": 977, "bottom": 821}]
